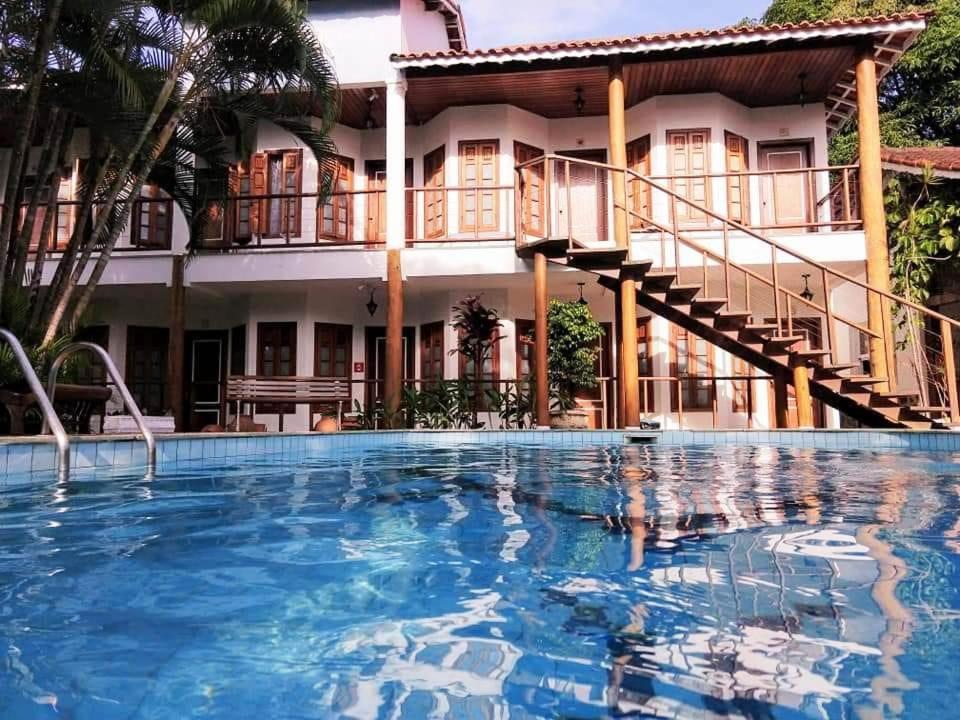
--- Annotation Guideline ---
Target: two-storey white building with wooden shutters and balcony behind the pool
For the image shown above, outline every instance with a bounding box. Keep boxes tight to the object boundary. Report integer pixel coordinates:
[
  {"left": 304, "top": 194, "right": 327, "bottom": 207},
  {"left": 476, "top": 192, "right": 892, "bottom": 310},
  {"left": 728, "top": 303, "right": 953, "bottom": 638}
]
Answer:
[{"left": 13, "top": 0, "right": 925, "bottom": 430}]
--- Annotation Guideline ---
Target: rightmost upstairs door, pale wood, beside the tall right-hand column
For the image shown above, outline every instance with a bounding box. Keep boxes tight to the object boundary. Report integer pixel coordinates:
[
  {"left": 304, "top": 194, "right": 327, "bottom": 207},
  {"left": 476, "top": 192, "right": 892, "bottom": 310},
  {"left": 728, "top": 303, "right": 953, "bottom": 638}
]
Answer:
[{"left": 758, "top": 143, "right": 812, "bottom": 228}]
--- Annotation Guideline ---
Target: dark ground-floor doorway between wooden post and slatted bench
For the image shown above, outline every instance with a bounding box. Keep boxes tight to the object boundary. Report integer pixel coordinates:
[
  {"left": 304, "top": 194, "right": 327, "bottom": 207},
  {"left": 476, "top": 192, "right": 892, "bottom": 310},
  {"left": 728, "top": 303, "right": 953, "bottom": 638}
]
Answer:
[{"left": 184, "top": 331, "right": 227, "bottom": 432}]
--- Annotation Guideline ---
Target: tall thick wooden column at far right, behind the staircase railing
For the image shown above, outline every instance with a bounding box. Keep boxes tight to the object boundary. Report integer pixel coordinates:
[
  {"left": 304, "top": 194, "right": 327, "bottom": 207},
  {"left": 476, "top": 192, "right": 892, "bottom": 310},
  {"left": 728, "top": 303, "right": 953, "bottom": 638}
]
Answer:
[{"left": 857, "top": 46, "right": 895, "bottom": 392}]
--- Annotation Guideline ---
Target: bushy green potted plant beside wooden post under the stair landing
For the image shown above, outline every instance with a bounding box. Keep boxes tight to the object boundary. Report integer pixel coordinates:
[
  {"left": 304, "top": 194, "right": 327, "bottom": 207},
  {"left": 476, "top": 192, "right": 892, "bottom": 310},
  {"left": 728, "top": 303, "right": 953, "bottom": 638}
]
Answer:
[{"left": 547, "top": 300, "right": 603, "bottom": 429}]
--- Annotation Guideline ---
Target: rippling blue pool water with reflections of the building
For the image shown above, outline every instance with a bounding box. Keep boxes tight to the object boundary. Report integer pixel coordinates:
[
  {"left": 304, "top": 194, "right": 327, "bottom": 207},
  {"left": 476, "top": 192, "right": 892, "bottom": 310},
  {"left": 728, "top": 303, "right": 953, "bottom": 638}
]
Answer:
[{"left": 0, "top": 438, "right": 960, "bottom": 720}]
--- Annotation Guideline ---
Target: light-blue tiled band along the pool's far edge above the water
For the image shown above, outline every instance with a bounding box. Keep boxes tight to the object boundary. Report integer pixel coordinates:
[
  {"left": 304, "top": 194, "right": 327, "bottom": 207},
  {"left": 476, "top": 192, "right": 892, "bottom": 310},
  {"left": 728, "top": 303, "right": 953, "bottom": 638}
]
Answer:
[{"left": 0, "top": 429, "right": 960, "bottom": 481}]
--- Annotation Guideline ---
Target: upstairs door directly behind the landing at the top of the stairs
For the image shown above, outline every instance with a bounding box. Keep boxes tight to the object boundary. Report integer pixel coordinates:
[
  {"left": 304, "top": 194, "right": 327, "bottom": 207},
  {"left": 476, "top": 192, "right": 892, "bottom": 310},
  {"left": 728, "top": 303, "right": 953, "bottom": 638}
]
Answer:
[{"left": 555, "top": 150, "right": 612, "bottom": 245}]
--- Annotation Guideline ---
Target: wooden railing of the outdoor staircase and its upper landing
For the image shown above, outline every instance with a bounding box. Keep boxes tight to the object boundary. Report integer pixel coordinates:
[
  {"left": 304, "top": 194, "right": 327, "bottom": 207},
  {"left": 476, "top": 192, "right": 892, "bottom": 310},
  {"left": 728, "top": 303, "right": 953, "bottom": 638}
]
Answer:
[{"left": 517, "top": 155, "right": 960, "bottom": 423}]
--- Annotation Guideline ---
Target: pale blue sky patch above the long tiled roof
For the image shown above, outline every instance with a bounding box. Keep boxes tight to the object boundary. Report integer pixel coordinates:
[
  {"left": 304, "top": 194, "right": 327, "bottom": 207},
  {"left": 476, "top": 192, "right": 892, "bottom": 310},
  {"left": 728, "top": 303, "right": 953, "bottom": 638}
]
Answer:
[{"left": 460, "top": 0, "right": 770, "bottom": 48}]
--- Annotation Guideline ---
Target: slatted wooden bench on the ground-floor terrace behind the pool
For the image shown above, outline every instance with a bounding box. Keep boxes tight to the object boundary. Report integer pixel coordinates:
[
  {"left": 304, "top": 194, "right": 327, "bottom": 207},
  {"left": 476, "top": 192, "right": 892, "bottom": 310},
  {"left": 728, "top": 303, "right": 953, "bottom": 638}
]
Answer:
[{"left": 227, "top": 375, "right": 351, "bottom": 432}]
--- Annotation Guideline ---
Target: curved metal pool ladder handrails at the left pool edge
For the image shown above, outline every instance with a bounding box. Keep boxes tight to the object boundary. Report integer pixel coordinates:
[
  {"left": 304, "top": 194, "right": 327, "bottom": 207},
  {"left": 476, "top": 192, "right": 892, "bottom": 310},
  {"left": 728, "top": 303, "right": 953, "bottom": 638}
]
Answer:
[{"left": 0, "top": 328, "right": 157, "bottom": 480}]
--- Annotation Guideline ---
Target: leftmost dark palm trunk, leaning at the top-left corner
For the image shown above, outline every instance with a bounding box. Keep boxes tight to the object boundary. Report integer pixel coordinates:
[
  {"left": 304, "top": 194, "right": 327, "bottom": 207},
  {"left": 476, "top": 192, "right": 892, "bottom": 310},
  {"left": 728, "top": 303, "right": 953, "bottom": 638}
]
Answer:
[{"left": 0, "top": 0, "right": 63, "bottom": 310}]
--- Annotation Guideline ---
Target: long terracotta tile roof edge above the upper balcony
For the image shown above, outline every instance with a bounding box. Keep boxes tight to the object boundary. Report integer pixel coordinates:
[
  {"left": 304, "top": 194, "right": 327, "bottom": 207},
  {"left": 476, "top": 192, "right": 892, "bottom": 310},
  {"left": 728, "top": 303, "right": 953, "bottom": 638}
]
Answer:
[{"left": 392, "top": 11, "right": 932, "bottom": 62}]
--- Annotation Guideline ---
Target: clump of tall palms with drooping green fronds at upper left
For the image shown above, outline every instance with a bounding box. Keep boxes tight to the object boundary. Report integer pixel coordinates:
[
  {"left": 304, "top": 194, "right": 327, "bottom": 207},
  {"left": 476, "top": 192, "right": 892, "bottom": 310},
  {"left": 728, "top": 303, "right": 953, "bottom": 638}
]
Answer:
[{"left": 0, "top": 0, "right": 338, "bottom": 345}]
